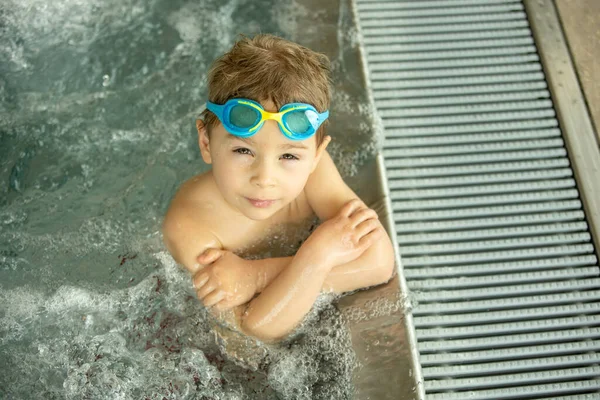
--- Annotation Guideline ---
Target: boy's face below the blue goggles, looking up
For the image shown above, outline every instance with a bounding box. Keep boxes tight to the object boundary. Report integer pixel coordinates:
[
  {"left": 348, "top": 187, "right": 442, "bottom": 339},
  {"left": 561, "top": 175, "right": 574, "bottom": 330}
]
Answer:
[{"left": 196, "top": 101, "right": 331, "bottom": 220}]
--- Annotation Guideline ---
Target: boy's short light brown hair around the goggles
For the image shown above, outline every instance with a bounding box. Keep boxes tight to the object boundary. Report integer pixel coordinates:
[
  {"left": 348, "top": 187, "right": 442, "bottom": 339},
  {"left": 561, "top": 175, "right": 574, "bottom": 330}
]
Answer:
[{"left": 201, "top": 34, "right": 331, "bottom": 146}]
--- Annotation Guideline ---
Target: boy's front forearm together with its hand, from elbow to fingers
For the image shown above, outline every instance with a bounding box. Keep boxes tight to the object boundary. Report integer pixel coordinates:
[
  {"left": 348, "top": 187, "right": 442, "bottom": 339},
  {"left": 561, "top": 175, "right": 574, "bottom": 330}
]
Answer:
[{"left": 234, "top": 199, "right": 383, "bottom": 340}]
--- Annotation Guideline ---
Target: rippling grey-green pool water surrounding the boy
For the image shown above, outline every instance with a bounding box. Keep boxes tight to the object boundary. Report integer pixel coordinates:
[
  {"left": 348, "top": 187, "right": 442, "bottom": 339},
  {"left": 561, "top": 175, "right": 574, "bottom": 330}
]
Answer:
[{"left": 0, "top": 0, "right": 412, "bottom": 399}]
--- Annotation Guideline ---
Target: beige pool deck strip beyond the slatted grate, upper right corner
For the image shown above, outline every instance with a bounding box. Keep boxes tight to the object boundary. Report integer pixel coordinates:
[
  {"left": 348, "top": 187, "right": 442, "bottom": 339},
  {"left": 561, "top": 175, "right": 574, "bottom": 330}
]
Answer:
[{"left": 524, "top": 0, "right": 600, "bottom": 255}]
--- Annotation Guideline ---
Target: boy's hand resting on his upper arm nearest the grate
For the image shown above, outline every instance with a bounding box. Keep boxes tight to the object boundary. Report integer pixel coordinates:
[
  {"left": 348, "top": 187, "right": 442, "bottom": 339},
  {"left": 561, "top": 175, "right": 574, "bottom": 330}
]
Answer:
[{"left": 298, "top": 199, "right": 383, "bottom": 268}]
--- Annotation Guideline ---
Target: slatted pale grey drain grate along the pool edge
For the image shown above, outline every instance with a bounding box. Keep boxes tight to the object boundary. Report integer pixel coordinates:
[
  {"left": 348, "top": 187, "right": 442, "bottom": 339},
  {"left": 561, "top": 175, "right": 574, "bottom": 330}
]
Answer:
[{"left": 356, "top": 0, "right": 600, "bottom": 400}]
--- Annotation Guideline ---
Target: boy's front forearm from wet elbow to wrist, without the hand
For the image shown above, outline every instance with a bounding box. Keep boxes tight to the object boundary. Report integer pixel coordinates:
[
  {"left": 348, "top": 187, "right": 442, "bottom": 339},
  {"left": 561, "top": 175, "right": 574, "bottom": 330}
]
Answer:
[{"left": 241, "top": 251, "right": 330, "bottom": 340}]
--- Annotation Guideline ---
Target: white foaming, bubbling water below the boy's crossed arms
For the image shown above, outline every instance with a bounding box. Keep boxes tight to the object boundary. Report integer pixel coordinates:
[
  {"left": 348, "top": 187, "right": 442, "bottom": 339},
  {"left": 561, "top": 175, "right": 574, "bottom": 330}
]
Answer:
[{"left": 0, "top": 245, "right": 354, "bottom": 399}]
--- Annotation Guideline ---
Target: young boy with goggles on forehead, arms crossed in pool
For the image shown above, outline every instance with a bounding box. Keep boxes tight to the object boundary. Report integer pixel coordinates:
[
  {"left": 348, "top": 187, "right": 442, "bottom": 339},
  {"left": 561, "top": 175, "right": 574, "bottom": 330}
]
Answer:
[{"left": 163, "top": 34, "right": 394, "bottom": 341}]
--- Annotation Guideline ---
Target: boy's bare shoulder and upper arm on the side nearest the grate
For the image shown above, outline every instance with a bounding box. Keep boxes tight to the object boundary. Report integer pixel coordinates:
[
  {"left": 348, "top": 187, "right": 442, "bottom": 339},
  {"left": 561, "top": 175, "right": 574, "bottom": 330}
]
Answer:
[{"left": 304, "top": 150, "right": 358, "bottom": 221}]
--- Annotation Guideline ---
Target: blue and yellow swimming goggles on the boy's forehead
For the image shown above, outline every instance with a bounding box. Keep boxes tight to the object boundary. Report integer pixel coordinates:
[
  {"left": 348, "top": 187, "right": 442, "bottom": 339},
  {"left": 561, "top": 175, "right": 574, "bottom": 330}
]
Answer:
[{"left": 206, "top": 99, "right": 329, "bottom": 140}]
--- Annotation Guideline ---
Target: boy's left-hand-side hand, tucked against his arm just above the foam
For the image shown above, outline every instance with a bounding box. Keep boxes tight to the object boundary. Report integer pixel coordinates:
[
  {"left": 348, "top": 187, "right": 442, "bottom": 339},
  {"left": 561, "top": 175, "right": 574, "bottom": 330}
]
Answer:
[{"left": 192, "top": 249, "right": 257, "bottom": 311}]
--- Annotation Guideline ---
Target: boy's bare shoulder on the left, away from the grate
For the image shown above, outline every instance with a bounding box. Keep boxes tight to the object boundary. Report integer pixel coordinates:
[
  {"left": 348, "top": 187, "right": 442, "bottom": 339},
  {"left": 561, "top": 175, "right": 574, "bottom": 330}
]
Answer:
[{"left": 163, "top": 171, "right": 223, "bottom": 271}]
